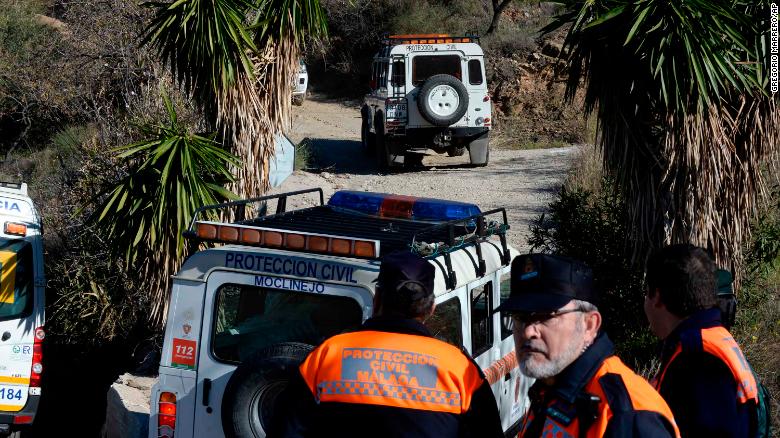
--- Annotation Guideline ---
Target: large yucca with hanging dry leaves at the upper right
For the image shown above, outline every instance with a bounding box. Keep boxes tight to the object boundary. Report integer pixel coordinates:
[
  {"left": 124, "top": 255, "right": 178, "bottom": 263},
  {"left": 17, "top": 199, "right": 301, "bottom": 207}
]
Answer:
[{"left": 545, "top": 0, "right": 780, "bottom": 280}]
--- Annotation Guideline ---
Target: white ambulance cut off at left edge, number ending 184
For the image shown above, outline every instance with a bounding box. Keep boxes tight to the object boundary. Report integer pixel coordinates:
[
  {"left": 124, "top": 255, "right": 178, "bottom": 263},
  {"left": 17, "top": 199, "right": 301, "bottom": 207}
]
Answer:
[{"left": 0, "top": 182, "right": 46, "bottom": 436}]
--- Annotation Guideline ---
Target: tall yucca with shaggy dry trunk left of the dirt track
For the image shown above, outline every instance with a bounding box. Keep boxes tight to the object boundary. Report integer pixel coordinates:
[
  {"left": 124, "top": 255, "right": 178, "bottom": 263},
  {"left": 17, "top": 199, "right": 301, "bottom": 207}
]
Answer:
[{"left": 142, "top": 0, "right": 327, "bottom": 197}]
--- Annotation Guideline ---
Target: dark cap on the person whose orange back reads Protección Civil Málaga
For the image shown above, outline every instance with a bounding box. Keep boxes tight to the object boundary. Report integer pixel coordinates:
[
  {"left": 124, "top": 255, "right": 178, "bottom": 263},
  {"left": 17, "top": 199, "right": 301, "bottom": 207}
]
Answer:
[{"left": 376, "top": 252, "right": 436, "bottom": 300}]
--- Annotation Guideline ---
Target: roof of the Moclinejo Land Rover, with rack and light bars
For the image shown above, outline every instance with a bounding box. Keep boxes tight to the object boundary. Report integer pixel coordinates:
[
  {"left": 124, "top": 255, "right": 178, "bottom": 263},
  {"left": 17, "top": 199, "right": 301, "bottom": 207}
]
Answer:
[{"left": 176, "top": 189, "right": 517, "bottom": 296}]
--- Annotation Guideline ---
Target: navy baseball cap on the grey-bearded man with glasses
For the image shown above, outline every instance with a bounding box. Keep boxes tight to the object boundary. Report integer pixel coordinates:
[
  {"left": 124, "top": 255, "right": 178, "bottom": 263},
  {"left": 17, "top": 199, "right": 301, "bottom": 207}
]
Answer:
[{"left": 496, "top": 254, "right": 598, "bottom": 312}]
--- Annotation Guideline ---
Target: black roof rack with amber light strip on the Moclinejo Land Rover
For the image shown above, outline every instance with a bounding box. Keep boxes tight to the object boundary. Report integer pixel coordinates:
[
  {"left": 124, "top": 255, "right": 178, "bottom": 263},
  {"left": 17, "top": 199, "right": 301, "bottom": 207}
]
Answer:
[{"left": 184, "top": 188, "right": 511, "bottom": 288}]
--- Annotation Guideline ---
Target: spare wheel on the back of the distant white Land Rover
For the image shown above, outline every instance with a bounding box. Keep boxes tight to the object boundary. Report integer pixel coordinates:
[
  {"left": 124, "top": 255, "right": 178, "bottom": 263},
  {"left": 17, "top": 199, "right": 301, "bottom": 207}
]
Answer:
[{"left": 417, "top": 74, "right": 469, "bottom": 126}]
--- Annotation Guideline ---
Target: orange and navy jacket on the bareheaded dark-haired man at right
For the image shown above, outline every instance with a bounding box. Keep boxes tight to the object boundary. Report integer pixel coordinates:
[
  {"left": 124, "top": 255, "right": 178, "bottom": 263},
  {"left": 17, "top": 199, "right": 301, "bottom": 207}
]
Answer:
[{"left": 653, "top": 308, "right": 758, "bottom": 437}]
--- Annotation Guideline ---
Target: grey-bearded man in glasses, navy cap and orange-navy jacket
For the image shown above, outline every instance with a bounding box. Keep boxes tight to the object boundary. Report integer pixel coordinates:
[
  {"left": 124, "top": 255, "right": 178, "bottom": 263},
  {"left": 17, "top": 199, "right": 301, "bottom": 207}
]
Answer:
[{"left": 497, "top": 254, "right": 679, "bottom": 438}]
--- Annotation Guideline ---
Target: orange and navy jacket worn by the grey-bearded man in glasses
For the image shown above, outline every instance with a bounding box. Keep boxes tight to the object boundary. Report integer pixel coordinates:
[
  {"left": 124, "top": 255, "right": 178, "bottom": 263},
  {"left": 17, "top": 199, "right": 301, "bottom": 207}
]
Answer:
[{"left": 519, "top": 333, "right": 680, "bottom": 438}]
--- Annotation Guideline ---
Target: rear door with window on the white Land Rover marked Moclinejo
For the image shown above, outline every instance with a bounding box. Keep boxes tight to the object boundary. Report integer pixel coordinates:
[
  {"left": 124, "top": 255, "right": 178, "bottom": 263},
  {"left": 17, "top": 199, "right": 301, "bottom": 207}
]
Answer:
[{"left": 190, "top": 271, "right": 371, "bottom": 437}]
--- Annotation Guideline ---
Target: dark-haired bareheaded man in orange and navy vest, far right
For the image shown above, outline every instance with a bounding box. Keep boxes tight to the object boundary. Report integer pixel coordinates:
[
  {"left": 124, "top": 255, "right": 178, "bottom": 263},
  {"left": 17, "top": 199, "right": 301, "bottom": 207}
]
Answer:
[{"left": 644, "top": 245, "right": 758, "bottom": 437}]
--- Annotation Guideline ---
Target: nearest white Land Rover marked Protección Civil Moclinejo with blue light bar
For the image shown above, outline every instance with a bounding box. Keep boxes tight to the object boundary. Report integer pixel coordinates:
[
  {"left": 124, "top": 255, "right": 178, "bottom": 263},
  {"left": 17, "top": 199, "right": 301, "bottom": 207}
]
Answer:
[{"left": 149, "top": 189, "right": 532, "bottom": 438}]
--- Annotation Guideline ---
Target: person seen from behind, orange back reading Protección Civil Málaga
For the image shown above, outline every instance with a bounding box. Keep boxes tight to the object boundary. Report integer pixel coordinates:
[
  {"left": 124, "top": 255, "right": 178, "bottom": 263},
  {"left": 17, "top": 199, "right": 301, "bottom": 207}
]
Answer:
[{"left": 269, "top": 252, "right": 503, "bottom": 438}]
